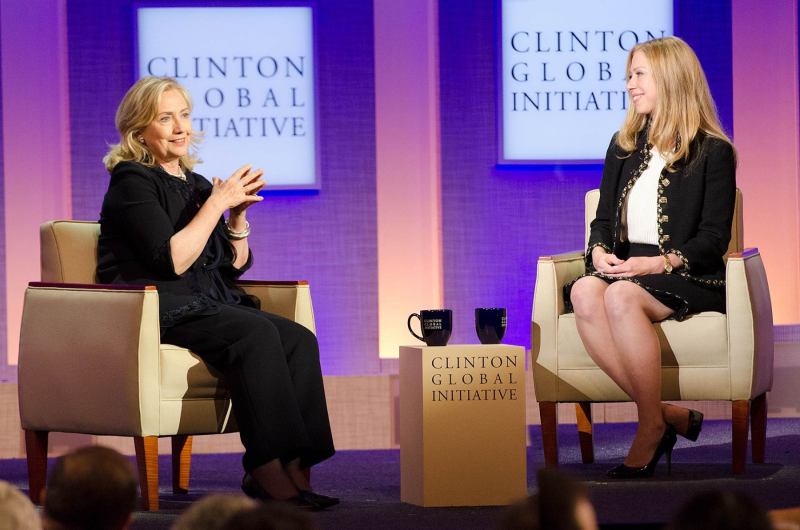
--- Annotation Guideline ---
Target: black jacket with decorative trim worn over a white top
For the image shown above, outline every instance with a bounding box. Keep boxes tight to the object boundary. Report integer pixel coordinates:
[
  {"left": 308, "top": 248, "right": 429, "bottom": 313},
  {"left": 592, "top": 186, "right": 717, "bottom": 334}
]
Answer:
[{"left": 586, "top": 129, "right": 736, "bottom": 286}]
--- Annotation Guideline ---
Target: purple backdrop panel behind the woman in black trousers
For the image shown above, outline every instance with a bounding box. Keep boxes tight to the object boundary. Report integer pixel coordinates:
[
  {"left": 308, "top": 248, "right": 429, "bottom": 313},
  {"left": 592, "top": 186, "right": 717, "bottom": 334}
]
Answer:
[{"left": 68, "top": 0, "right": 380, "bottom": 374}]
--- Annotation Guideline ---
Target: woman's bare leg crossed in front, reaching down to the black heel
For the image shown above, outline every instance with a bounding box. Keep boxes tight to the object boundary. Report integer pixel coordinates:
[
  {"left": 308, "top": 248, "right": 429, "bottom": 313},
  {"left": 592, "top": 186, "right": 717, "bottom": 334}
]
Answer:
[{"left": 604, "top": 281, "right": 672, "bottom": 467}]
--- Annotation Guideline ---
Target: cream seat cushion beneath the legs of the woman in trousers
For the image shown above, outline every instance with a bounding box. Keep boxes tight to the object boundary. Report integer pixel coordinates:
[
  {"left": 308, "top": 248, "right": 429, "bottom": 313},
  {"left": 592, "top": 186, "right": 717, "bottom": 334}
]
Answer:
[{"left": 160, "top": 344, "right": 229, "bottom": 400}]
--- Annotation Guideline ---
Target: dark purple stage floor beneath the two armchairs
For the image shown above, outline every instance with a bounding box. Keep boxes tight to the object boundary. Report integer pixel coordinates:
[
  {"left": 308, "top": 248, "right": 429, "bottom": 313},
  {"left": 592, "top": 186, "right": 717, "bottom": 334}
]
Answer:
[{"left": 0, "top": 419, "right": 800, "bottom": 530}]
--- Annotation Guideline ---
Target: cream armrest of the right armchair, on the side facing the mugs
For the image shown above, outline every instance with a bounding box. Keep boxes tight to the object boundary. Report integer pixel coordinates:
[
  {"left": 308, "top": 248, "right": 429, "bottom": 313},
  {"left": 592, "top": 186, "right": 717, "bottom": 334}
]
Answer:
[{"left": 531, "top": 252, "right": 586, "bottom": 401}]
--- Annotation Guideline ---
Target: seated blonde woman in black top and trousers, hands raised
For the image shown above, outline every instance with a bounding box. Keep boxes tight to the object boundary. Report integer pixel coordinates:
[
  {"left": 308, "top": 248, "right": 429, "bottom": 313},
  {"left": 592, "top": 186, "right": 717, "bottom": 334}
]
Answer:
[{"left": 97, "top": 77, "right": 338, "bottom": 508}]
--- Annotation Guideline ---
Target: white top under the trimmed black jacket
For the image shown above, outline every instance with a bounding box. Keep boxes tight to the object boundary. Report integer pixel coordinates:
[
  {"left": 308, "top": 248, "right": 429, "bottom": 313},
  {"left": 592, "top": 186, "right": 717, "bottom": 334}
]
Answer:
[{"left": 623, "top": 147, "right": 667, "bottom": 245}]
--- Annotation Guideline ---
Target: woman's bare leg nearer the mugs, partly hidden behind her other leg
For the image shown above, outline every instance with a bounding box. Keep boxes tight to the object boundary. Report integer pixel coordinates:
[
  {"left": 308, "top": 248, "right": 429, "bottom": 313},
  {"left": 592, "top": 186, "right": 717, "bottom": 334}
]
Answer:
[{"left": 570, "top": 276, "right": 633, "bottom": 398}]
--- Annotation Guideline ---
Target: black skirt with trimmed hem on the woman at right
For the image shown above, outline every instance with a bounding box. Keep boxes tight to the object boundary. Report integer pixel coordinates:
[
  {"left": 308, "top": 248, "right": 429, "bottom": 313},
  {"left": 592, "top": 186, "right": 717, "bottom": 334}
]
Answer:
[{"left": 564, "top": 243, "right": 725, "bottom": 320}]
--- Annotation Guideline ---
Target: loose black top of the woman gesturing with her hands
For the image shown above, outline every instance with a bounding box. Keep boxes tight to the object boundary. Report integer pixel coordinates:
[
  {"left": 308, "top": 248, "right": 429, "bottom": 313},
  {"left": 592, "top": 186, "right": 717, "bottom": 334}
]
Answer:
[{"left": 97, "top": 162, "right": 253, "bottom": 328}]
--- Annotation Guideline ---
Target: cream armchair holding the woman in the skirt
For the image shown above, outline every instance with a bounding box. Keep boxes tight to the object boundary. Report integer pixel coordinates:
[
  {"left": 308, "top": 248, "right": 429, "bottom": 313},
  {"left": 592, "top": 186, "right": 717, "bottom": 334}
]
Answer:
[{"left": 531, "top": 190, "right": 773, "bottom": 473}]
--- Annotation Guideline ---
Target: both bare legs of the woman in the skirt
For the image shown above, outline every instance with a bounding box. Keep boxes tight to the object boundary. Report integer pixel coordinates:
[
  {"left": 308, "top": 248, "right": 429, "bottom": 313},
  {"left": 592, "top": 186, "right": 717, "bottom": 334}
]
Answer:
[{"left": 570, "top": 276, "right": 686, "bottom": 467}]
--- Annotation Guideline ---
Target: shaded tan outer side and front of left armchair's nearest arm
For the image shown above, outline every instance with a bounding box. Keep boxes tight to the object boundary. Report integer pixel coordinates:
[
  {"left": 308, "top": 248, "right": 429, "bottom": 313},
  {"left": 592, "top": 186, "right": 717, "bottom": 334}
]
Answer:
[{"left": 19, "top": 282, "right": 160, "bottom": 436}]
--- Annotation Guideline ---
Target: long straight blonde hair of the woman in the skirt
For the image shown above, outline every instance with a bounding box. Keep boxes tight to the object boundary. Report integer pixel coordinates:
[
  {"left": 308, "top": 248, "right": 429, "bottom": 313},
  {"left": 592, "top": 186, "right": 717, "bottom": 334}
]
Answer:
[{"left": 617, "top": 37, "right": 731, "bottom": 171}]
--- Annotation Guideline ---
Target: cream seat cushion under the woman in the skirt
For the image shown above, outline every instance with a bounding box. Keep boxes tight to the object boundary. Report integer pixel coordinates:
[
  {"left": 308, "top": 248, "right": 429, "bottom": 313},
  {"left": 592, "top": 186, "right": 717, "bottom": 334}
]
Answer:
[{"left": 558, "top": 311, "right": 730, "bottom": 370}]
